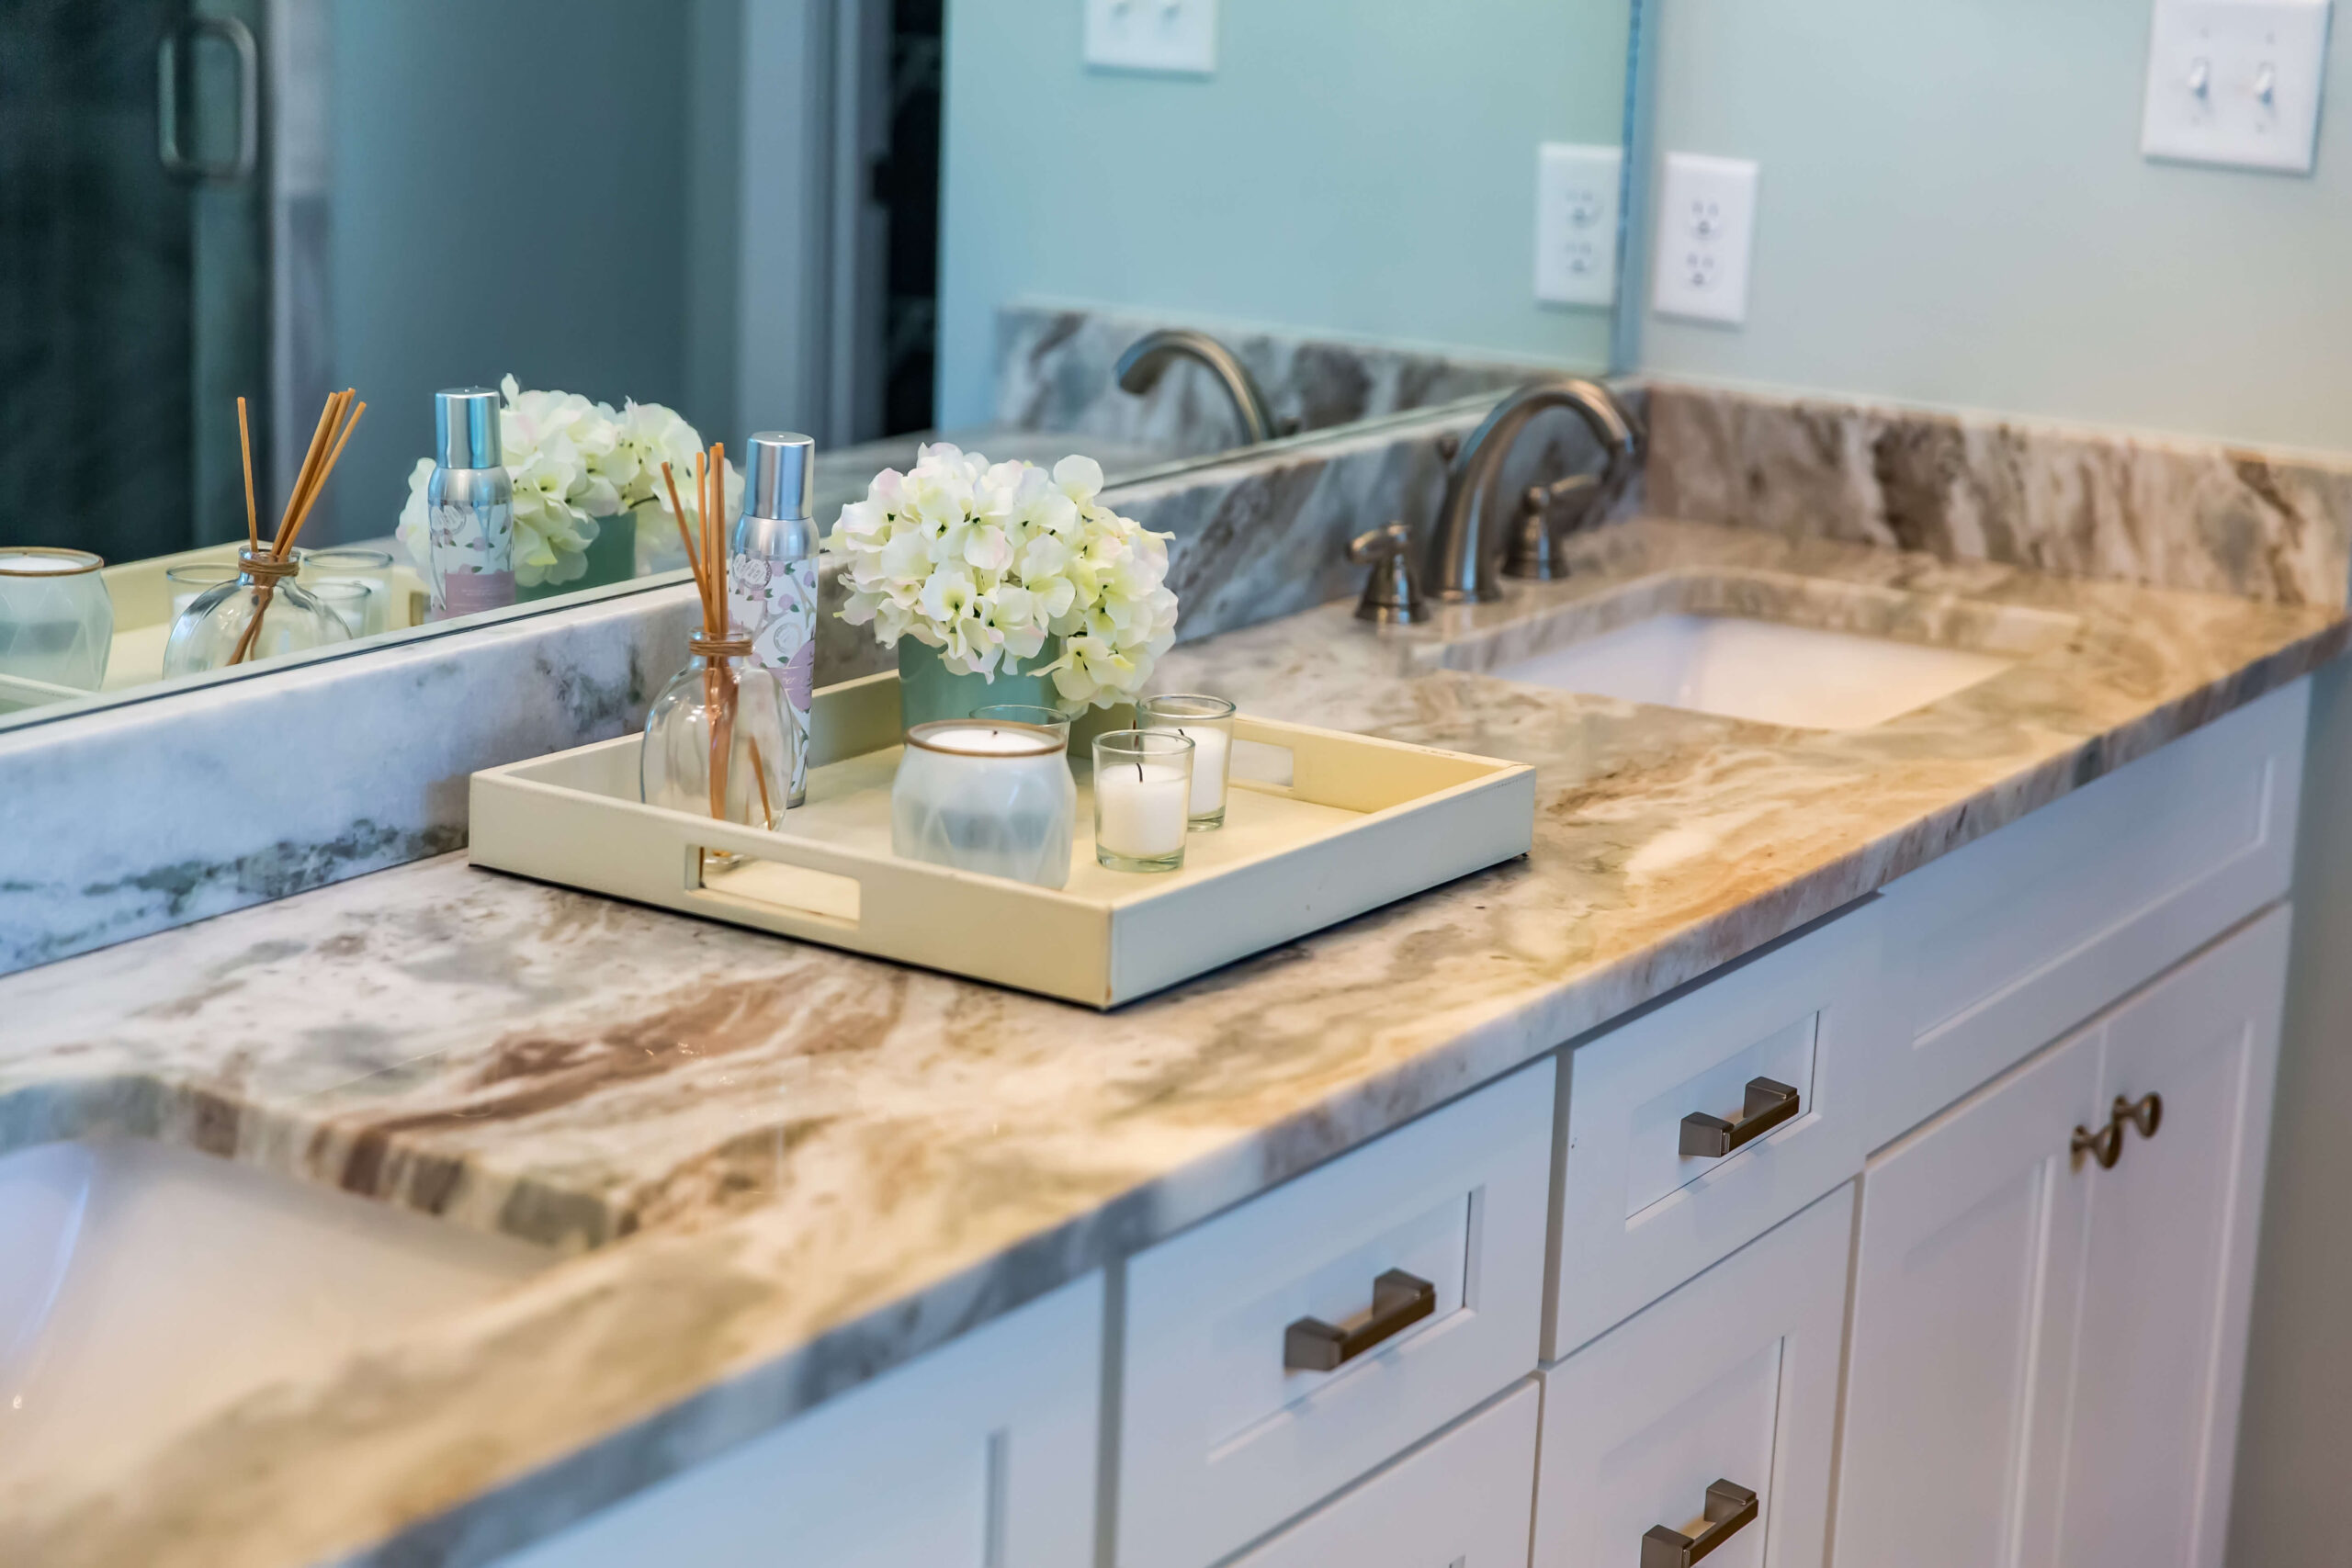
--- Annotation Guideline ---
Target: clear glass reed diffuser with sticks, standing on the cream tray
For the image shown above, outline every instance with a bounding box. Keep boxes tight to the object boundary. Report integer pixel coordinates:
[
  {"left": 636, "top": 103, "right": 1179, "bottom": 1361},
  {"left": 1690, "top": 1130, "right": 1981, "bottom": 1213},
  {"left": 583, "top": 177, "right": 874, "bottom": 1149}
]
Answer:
[{"left": 638, "top": 446, "right": 795, "bottom": 861}]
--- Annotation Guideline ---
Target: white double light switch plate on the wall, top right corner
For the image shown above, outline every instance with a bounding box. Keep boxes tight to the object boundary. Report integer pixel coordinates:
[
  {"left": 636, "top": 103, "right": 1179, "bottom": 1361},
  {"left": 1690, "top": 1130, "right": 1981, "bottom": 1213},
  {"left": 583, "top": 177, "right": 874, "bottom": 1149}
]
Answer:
[{"left": 2141, "top": 0, "right": 2328, "bottom": 174}]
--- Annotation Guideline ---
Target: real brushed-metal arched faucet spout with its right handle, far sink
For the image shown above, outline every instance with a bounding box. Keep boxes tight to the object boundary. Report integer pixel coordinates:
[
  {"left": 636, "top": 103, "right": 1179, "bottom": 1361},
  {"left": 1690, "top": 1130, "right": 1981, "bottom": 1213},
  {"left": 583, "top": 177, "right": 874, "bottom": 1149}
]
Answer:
[{"left": 1428, "top": 376, "right": 1642, "bottom": 602}]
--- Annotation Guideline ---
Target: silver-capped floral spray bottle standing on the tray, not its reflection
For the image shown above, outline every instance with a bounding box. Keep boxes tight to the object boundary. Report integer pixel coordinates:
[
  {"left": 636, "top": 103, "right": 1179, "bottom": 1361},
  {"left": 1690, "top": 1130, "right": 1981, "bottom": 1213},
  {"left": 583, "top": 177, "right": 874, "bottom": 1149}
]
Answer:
[{"left": 727, "top": 430, "right": 816, "bottom": 807}]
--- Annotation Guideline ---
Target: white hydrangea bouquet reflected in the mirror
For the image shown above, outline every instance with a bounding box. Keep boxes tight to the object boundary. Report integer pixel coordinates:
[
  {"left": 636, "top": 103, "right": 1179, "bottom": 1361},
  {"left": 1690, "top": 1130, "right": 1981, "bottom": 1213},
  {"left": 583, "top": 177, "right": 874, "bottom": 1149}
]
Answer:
[{"left": 400, "top": 376, "right": 743, "bottom": 588}]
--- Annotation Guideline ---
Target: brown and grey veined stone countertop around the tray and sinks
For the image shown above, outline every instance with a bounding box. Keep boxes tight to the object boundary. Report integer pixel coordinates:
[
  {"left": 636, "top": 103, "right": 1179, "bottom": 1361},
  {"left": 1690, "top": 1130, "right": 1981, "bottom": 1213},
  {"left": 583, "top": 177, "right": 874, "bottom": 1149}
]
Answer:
[{"left": 0, "top": 520, "right": 2345, "bottom": 1568}]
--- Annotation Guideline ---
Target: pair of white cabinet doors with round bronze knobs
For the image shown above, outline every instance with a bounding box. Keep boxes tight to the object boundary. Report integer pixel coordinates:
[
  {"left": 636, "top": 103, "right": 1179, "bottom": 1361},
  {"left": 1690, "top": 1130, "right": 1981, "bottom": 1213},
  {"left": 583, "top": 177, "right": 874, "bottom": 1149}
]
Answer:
[{"left": 1837, "top": 908, "right": 2289, "bottom": 1568}]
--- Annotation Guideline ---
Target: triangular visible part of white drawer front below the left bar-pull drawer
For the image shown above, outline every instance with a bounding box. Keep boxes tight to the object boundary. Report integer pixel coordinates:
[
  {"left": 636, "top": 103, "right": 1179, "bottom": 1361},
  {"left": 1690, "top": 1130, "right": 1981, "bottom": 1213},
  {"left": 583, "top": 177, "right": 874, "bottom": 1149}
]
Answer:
[{"left": 1232, "top": 1380, "right": 1541, "bottom": 1568}]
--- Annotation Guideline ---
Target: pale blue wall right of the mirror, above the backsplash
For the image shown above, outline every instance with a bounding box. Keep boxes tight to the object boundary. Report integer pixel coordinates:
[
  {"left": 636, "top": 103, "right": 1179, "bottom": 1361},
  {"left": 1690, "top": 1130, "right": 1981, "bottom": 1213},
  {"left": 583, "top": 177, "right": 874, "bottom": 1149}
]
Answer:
[{"left": 1637, "top": 0, "right": 2352, "bottom": 449}]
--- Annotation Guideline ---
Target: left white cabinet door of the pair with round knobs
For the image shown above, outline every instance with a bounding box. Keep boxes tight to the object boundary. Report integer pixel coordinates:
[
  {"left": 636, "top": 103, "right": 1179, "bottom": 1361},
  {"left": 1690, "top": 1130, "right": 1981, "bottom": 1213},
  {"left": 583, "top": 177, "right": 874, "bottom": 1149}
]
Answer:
[{"left": 1837, "top": 1010, "right": 2100, "bottom": 1568}]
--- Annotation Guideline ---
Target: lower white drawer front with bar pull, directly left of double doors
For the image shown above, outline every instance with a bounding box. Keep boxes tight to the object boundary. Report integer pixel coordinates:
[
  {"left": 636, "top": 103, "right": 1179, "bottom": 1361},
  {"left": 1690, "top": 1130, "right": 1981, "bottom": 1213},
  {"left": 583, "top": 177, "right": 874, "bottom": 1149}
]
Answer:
[{"left": 1533, "top": 1185, "right": 1853, "bottom": 1568}]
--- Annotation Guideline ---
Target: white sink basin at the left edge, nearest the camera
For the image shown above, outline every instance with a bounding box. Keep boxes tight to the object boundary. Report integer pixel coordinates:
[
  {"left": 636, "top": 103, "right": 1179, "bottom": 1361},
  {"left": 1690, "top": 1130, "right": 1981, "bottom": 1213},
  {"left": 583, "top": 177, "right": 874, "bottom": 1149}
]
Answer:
[{"left": 0, "top": 1138, "right": 555, "bottom": 1483}]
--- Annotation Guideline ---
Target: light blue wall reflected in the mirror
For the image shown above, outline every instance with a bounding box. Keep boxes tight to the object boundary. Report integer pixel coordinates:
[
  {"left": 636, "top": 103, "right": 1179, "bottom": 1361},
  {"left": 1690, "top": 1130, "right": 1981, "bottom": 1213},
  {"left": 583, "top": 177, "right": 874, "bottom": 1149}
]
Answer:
[{"left": 938, "top": 0, "right": 1628, "bottom": 425}]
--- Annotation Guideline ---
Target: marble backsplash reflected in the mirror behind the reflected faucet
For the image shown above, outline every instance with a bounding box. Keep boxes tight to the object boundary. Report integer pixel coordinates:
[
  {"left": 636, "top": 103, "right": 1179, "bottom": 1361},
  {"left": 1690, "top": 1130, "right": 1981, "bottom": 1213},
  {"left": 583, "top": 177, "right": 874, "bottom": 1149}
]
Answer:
[{"left": 995, "top": 306, "right": 1555, "bottom": 456}]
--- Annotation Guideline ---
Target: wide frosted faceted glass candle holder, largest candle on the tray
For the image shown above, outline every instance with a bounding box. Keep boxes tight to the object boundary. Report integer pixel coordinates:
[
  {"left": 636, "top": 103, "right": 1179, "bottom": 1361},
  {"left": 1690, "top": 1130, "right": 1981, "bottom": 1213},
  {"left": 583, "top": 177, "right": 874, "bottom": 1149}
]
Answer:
[{"left": 889, "top": 717, "right": 1077, "bottom": 888}]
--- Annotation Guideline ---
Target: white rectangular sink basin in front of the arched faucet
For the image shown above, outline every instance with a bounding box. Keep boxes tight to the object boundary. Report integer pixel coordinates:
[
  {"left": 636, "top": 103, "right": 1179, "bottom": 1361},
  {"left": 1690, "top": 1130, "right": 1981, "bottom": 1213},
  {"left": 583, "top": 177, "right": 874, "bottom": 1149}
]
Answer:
[{"left": 1437, "top": 571, "right": 2072, "bottom": 728}]
